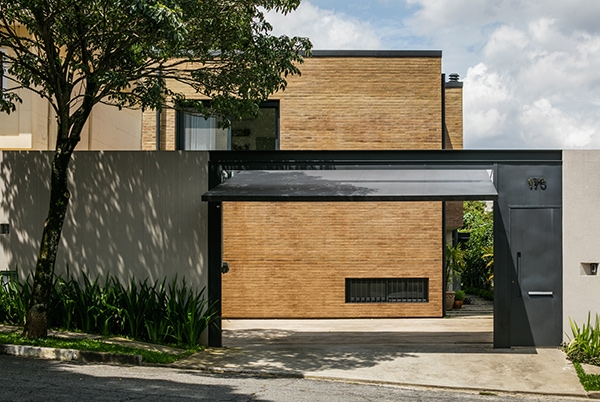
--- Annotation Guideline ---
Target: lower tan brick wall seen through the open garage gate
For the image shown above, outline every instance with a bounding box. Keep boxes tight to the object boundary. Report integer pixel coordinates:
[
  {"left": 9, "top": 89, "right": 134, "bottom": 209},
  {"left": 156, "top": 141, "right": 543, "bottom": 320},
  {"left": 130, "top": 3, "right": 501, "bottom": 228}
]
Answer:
[{"left": 223, "top": 202, "right": 443, "bottom": 318}]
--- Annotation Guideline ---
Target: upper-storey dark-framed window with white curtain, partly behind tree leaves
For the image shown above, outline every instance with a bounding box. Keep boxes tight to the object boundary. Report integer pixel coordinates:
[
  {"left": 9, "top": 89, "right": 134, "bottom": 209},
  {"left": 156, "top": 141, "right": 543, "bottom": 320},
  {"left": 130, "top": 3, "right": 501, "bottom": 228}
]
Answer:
[{"left": 176, "top": 101, "right": 279, "bottom": 151}]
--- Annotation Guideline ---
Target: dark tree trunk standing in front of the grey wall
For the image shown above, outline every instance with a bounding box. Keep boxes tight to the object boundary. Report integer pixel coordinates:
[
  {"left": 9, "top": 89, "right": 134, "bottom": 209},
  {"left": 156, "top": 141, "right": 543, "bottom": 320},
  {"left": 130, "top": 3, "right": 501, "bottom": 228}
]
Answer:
[{"left": 23, "top": 147, "right": 73, "bottom": 339}]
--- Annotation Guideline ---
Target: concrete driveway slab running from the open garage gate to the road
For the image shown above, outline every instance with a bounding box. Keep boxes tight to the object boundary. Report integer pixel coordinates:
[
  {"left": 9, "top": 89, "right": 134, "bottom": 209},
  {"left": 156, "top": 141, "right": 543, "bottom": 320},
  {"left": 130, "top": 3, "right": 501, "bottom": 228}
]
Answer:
[{"left": 175, "top": 317, "right": 587, "bottom": 397}]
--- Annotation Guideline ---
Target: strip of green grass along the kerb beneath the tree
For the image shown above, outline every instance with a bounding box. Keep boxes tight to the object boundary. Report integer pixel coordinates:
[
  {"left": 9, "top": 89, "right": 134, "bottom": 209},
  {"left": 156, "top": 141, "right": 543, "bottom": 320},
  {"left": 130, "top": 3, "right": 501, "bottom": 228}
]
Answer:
[{"left": 0, "top": 332, "right": 200, "bottom": 364}]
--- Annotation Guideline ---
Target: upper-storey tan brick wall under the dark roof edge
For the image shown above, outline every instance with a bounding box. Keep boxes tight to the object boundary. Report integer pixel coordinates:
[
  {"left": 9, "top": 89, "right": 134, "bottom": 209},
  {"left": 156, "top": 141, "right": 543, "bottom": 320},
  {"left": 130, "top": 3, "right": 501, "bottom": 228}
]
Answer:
[{"left": 272, "top": 57, "right": 440, "bottom": 150}]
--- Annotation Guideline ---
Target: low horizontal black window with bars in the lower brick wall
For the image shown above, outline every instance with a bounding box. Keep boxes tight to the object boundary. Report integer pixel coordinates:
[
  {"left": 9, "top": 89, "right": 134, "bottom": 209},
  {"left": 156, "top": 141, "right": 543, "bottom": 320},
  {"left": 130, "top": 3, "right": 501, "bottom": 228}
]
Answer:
[{"left": 346, "top": 278, "right": 429, "bottom": 303}]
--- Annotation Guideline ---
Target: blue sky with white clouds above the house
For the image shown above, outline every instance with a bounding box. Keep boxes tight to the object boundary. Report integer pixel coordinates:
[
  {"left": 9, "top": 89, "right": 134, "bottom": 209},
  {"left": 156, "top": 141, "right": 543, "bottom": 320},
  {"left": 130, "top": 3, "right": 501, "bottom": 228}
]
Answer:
[{"left": 267, "top": 0, "right": 600, "bottom": 149}]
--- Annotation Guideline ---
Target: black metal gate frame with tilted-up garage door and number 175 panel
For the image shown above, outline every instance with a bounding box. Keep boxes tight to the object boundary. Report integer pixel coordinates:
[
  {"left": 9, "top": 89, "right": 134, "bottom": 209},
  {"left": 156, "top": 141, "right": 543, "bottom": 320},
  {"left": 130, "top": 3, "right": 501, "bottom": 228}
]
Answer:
[{"left": 203, "top": 151, "right": 562, "bottom": 347}]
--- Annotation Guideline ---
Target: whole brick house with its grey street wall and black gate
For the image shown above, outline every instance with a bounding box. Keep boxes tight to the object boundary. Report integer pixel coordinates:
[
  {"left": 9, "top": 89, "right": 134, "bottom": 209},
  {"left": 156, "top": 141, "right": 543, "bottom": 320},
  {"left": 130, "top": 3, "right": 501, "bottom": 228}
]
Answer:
[{"left": 0, "top": 48, "right": 600, "bottom": 347}]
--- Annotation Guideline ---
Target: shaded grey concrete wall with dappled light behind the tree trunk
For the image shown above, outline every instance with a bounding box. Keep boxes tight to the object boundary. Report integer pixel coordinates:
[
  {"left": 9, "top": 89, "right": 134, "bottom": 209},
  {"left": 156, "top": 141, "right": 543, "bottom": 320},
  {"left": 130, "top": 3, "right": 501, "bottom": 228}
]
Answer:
[{"left": 0, "top": 151, "right": 208, "bottom": 288}]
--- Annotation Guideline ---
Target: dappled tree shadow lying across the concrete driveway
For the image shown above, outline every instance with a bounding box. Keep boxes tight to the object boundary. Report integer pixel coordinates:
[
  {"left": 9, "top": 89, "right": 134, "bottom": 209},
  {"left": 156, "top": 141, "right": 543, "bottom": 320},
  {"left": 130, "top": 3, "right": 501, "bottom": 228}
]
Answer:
[{"left": 176, "top": 329, "right": 536, "bottom": 376}]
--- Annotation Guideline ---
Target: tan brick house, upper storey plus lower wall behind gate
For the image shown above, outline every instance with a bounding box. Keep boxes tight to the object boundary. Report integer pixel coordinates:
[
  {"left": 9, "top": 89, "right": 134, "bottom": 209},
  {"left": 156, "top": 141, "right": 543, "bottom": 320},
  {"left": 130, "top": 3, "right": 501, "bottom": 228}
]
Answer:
[{"left": 143, "top": 51, "right": 463, "bottom": 318}]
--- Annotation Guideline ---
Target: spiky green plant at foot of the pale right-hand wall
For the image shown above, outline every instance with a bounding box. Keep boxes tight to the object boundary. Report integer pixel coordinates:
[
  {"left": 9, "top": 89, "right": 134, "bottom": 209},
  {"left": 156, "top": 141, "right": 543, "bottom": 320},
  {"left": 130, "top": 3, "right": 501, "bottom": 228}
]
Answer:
[{"left": 564, "top": 313, "right": 600, "bottom": 366}]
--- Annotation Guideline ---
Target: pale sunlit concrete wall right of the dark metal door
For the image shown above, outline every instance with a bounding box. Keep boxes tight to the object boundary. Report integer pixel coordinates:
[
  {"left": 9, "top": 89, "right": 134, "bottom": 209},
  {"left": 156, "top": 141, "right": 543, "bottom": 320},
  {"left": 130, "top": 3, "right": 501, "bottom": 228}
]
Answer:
[{"left": 563, "top": 151, "right": 600, "bottom": 340}]
